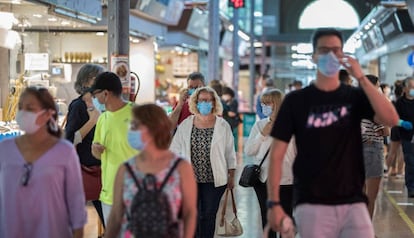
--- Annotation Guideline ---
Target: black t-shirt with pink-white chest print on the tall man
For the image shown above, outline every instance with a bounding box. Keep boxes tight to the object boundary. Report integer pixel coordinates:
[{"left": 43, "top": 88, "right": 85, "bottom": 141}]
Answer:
[{"left": 271, "top": 84, "right": 374, "bottom": 205}]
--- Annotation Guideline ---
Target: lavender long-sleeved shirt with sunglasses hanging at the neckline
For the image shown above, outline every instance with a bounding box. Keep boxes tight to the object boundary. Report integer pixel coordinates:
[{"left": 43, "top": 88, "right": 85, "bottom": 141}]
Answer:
[{"left": 0, "top": 138, "right": 87, "bottom": 238}]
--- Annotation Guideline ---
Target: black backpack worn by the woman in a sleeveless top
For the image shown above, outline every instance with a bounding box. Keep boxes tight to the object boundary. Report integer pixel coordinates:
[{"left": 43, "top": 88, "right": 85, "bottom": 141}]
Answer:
[{"left": 125, "top": 159, "right": 181, "bottom": 238}]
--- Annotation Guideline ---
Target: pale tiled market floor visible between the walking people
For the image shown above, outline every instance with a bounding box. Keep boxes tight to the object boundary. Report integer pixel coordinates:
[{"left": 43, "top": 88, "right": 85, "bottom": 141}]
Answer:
[{"left": 85, "top": 155, "right": 414, "bottom": 238}]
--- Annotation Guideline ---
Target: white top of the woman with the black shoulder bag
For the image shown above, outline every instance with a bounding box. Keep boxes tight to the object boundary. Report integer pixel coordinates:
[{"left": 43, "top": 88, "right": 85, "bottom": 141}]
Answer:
[{"left": 244, "top": 117, "right": 296, "bottom": 185}]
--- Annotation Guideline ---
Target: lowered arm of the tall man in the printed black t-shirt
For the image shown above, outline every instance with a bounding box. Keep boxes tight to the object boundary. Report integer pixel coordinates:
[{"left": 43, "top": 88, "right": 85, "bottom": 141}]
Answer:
[{"left": 267, "top": 139, "right": 288, "bottom": 231}]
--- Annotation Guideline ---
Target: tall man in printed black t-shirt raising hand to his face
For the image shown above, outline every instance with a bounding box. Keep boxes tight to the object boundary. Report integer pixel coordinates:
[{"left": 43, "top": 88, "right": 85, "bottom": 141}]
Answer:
[{"left": 268, "top": 28, "right": 398, "bottom": 238}]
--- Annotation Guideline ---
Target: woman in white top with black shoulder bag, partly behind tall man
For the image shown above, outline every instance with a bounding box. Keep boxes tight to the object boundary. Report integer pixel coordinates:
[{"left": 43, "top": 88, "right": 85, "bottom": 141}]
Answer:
[{"left": 244, "top": 89, "right": 296, "bottom": 238}]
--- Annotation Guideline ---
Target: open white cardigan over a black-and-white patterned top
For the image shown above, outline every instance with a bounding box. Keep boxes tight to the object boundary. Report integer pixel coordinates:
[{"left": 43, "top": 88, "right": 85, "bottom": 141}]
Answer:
[{"left": 170, "top": 115, "right": 237, "bottom": 187}]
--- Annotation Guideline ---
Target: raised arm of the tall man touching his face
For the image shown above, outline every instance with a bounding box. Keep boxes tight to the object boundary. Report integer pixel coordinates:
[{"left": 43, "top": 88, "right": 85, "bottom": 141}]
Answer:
[{"left": 341, "top": 56, "right": 399, "bottom": 126}]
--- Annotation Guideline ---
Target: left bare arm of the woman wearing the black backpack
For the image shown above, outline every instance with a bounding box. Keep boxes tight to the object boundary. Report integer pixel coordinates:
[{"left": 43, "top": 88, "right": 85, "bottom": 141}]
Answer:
[{"left": 105, "top": 165, "right": 126, "bottom": 238}]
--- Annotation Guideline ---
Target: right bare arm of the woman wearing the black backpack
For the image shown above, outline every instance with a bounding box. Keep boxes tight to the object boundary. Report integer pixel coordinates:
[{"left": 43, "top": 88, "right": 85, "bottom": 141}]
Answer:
[{"left": 178, "top": 161, "right": 197, "bottom": 238}]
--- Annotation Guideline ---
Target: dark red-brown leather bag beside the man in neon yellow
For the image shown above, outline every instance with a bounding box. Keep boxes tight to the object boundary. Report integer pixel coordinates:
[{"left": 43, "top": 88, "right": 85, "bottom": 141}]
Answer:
[{"left": 81, "top": 165, "right": 102, "bottom": 201}]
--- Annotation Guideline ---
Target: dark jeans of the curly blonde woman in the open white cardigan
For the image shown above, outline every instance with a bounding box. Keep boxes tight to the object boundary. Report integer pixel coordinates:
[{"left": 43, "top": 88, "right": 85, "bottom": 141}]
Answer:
[{"left": 196, "top": 183, "right": 227, "bottom": 238}]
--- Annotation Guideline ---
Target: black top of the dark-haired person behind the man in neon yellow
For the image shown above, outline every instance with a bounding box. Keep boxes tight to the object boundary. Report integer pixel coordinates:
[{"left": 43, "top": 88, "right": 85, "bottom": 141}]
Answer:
[{"left": 65, "top": 97, "right": 101, "bottom": 166}]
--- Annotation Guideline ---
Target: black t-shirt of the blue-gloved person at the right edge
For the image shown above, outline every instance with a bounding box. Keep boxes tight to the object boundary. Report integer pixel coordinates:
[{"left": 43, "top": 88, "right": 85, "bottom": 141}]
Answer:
[{"left": 395, "top": 97, "right": 414, "bottom": 141}]
